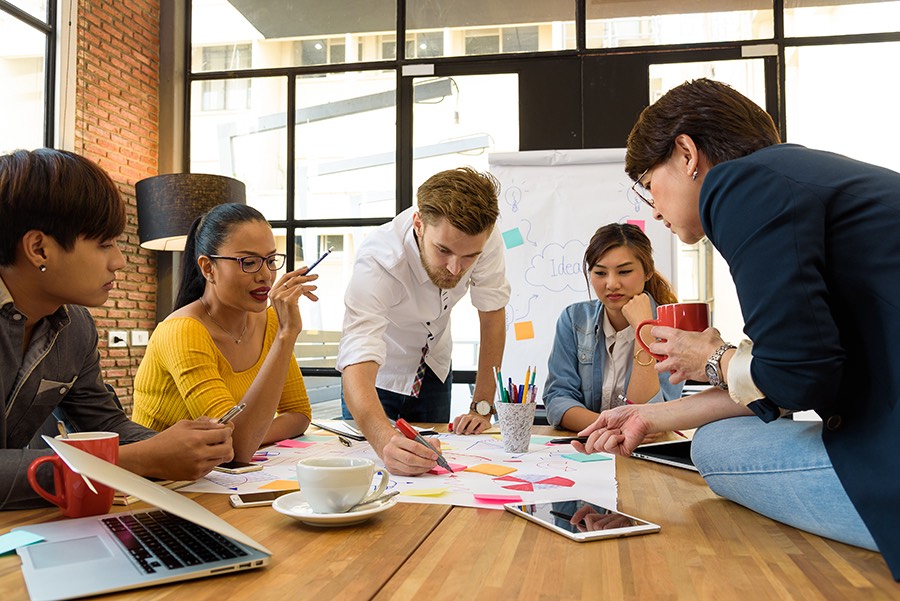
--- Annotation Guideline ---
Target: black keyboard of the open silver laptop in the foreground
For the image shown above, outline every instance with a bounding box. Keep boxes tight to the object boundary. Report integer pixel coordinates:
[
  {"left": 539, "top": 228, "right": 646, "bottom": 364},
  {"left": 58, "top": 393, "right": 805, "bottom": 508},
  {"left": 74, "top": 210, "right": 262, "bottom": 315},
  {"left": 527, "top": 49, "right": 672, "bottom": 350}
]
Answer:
[{"left": 102, "top": 510, "right": 247, "bottom": 574}]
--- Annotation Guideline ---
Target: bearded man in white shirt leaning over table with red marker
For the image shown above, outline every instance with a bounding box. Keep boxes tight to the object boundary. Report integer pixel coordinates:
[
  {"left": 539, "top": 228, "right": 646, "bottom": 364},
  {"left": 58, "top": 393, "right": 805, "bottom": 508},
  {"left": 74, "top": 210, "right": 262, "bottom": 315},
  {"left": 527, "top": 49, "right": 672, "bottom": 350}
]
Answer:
[{"left": 337, "top": 167, "right": 509, "bottom": 475}]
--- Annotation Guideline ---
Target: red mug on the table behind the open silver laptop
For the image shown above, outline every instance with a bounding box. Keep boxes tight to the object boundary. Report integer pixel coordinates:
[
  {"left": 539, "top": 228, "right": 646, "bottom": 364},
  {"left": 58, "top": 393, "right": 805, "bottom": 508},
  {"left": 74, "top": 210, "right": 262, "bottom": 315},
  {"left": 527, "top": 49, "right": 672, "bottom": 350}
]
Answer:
[{"left": 28, "top": 432, "right": 119, "bottom": 518}]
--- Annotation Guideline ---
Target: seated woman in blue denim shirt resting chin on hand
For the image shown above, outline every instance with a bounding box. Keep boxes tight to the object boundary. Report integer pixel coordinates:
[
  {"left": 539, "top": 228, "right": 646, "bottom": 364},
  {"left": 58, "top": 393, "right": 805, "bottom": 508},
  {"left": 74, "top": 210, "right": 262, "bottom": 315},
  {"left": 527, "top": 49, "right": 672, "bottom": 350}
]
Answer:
[{"left": 544, "top": 223, "right": 683, "bottom": 432}]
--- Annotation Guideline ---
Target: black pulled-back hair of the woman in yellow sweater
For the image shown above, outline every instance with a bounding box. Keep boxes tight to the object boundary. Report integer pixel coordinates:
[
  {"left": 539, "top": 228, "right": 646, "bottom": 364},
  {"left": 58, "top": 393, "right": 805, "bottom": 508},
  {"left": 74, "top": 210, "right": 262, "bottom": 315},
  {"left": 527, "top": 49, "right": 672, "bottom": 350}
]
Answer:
[{"left": 175, "top": 202, "right": 269, "bottom": 309}]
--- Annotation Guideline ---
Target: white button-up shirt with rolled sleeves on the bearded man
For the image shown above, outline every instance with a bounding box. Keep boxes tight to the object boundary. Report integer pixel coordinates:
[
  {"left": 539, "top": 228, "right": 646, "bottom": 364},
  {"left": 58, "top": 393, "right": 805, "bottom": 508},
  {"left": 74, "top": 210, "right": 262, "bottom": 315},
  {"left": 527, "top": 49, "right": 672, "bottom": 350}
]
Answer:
[{"left": 336, "top": 207, "right": 510, "bottom": 394}]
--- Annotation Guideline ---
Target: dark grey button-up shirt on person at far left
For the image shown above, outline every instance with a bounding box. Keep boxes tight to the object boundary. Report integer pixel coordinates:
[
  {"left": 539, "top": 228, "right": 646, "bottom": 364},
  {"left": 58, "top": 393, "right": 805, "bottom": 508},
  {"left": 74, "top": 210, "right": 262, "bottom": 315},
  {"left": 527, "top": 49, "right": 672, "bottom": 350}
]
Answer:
[{"left": 0, "top": 279, "right": 155, "bottom": 509}]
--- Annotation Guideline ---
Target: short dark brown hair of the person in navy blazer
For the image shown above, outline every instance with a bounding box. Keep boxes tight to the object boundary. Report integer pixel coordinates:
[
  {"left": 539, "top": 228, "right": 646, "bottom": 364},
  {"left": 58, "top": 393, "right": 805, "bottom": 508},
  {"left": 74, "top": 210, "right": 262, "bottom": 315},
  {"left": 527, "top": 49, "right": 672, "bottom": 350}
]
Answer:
[{"left": 625, "top": 78, "right": 781, "bottom": 181}]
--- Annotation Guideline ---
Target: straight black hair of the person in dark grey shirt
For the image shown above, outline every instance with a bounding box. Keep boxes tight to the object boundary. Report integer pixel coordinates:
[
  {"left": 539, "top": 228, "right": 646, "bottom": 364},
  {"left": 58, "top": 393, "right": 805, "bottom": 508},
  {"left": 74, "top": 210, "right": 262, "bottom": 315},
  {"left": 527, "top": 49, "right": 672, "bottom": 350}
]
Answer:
[{"left": 0, "top": 148, "right": 126, "bottom": 266}]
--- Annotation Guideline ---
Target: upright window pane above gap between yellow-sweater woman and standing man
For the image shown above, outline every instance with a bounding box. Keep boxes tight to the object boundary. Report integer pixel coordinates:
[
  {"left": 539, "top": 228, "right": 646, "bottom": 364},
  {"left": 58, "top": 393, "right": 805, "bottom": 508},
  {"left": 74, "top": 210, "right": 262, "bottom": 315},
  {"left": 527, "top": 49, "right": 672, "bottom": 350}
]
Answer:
[{"left": 294, "top": 71, "right": 397, "bottom": 219}]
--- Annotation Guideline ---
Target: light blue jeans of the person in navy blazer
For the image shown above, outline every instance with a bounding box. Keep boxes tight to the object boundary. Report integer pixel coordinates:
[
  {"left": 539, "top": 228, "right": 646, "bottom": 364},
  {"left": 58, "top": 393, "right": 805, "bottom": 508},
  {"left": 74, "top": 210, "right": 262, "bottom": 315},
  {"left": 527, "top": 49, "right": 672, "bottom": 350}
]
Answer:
[{"left": 691, "top": 417, "right": 878, "bottom": 551}]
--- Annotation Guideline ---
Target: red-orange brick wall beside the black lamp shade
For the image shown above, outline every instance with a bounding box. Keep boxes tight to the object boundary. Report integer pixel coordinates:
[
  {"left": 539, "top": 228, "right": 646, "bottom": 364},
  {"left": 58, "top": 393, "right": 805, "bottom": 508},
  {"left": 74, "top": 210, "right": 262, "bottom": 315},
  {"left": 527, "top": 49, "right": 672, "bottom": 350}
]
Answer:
[{"left": 75, "top": 0, "right": 159, "bottom": 413}]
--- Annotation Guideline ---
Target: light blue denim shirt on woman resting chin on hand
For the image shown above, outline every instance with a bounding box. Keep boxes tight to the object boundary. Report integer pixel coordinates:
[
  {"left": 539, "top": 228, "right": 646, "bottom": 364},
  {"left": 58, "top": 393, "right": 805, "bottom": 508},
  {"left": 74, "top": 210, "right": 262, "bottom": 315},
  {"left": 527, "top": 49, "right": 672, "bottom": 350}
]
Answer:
[{"left": 544, "top": 298, "right": 684, "bottom": 427}]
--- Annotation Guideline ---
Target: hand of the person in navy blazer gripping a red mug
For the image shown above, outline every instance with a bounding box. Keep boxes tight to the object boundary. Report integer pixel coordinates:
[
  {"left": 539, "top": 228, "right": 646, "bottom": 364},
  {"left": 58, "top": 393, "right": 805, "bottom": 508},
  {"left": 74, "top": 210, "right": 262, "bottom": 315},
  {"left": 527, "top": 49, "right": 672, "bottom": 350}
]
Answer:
[{"left": 650, "top": 326, "right": 723, "bottom": 384}]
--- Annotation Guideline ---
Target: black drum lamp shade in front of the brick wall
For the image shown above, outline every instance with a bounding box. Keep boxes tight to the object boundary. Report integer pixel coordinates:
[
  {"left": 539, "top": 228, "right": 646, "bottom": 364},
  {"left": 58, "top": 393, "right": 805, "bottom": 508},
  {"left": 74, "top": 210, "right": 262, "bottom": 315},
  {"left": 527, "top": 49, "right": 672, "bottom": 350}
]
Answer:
[{"left": 135, "top": 173, "right": 247, "bottom": 251}]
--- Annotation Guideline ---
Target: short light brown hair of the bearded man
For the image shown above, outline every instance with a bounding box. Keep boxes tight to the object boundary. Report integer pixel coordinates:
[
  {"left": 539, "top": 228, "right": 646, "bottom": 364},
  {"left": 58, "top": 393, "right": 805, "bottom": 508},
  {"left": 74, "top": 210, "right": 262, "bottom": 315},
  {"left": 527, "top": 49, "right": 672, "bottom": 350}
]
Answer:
[{"left": 416, "top": 167, "right": 500, "bottom": 236}]
